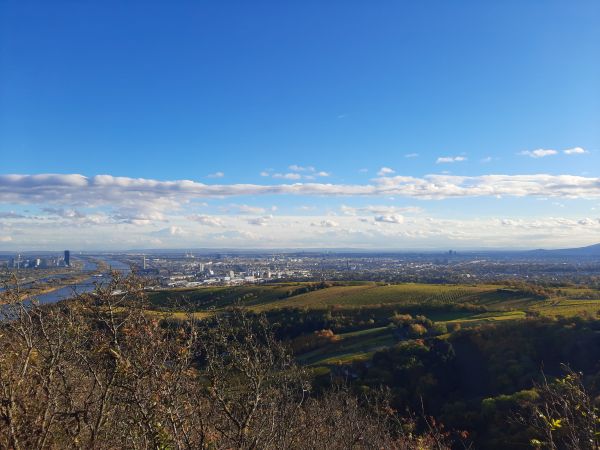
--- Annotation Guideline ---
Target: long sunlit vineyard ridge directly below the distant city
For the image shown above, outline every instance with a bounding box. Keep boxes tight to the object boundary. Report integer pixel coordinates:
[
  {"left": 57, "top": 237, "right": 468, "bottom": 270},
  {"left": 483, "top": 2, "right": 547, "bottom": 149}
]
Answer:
[{"left": 150, "top": 282, "right": 600, "bottom": 322}]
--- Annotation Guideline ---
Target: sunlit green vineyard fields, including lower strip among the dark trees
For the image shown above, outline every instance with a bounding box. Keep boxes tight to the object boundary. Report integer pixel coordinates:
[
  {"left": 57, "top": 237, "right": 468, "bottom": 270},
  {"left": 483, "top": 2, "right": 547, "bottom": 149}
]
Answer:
[{"left": 150, "top": 282, "right": 600, "bottom": 367}]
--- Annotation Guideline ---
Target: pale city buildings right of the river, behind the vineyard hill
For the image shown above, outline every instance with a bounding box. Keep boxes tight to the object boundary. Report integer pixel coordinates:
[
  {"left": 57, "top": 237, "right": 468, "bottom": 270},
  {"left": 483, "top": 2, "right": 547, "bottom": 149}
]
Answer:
[{"left": 116, "top": 250, "right": 600, "bottom": 287}]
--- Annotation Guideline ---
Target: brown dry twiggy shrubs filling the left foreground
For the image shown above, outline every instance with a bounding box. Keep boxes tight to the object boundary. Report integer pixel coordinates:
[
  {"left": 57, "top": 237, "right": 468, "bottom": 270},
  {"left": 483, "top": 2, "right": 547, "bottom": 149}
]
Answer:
[{"left": 0, "top": 274, "right": 447, "bottom": 450}]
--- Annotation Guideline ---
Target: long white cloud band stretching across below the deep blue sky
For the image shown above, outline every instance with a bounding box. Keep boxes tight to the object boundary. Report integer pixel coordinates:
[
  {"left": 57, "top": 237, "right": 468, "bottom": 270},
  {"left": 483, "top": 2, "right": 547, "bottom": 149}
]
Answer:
[{"left": 0, "top": 174, "right": 600, "bottom": 212}]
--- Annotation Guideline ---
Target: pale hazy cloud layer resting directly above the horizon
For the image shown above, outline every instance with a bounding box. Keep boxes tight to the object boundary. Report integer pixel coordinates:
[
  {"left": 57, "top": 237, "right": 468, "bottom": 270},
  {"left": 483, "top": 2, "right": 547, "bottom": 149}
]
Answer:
[{"left": 0, "top": 204, "right": 600, "bottom": 251}]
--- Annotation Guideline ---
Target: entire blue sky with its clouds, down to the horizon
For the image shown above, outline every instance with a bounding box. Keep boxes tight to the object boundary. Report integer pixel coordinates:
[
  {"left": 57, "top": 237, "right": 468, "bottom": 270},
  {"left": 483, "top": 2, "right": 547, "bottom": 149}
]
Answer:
[{"left": 0, "top": 1, "right": 600, "bottom": 249}]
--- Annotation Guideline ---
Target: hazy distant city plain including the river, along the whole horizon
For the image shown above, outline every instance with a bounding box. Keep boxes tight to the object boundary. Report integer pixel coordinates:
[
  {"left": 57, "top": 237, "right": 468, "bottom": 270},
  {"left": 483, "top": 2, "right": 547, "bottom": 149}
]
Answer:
[{"left": 0, "top": 246, "right": 600, "bottom": 301}]
